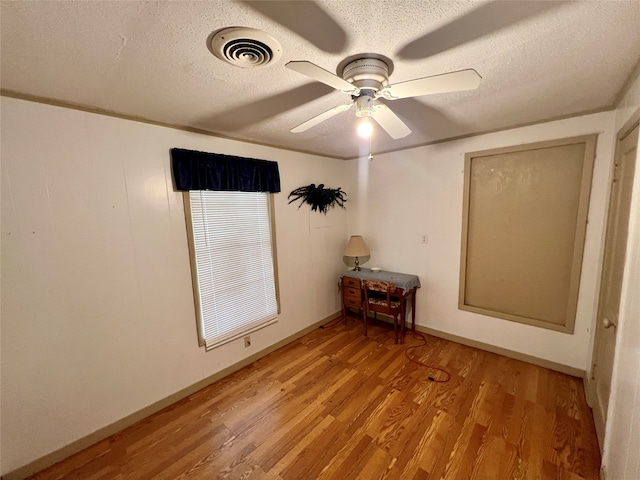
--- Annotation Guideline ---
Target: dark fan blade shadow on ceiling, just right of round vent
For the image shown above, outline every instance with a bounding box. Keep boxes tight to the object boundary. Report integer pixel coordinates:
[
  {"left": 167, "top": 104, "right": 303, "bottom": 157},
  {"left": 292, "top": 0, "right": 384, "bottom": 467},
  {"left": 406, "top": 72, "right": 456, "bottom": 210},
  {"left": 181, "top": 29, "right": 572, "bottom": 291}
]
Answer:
[{"left": 242, "top": 0, "right": 347, "bottom": 53}]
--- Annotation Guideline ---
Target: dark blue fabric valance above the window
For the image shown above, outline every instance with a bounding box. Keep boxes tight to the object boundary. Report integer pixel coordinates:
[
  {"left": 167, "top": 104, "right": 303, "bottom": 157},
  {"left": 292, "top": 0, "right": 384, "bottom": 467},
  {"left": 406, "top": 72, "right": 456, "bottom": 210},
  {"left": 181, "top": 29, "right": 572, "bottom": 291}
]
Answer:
[{"left": 171, "top": 148, "right": 280, "bottom": 193}]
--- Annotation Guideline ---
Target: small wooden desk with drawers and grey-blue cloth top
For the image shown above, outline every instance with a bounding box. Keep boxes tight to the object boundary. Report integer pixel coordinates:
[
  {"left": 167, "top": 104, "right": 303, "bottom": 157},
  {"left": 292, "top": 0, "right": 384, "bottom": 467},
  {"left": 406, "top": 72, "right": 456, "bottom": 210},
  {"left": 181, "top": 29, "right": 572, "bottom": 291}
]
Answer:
[{"left": 341, "top": 268, "right": 420, "bottom": 343}]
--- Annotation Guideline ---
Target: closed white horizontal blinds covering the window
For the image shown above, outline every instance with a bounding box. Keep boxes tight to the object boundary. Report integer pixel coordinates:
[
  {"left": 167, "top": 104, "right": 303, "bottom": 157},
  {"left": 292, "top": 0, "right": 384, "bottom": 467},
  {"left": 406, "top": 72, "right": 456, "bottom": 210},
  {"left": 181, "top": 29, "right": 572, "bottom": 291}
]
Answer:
[{"left": 189, "top": 191, "right": 278, "bottom": 350}]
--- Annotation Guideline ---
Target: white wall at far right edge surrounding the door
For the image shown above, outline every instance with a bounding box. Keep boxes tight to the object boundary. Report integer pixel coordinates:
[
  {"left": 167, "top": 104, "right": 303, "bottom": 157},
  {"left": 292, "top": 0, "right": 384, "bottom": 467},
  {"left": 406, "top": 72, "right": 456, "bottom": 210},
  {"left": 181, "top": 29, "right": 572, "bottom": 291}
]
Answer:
[{"left": 602, "top": 71, "right": 640, "bottom": 480}]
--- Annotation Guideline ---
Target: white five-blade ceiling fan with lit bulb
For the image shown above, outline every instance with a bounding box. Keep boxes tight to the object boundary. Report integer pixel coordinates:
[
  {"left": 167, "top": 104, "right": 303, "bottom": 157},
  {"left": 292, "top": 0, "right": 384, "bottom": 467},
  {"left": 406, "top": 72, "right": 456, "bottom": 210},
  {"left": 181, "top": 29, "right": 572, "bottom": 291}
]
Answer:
[{"left": 285, "top": 54, "right": 481, "bottom": 139}]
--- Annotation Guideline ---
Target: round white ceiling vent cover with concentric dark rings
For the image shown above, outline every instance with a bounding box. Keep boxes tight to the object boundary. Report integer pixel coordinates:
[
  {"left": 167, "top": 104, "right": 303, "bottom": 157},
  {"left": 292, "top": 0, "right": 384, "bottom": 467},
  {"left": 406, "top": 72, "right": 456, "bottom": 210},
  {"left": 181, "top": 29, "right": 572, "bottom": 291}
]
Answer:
[{"left": 208, "top": 27, "right": 282, "bottom": 68}]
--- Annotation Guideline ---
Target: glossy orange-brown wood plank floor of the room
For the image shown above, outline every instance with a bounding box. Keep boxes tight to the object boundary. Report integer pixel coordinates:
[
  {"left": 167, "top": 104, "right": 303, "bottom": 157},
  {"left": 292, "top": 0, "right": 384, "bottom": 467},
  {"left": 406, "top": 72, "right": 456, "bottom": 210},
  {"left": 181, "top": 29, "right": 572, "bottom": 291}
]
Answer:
[{"left": 32, "top": 319, "right": 600, "bottom": 480}]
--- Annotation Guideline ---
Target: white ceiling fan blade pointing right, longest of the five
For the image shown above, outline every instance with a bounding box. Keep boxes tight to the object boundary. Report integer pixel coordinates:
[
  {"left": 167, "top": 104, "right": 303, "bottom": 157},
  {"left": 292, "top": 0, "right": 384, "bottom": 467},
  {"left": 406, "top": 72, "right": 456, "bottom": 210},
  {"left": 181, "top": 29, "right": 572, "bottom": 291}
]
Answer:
[{"left": 381, "top": 69, "right": 482, "bottom": 100}]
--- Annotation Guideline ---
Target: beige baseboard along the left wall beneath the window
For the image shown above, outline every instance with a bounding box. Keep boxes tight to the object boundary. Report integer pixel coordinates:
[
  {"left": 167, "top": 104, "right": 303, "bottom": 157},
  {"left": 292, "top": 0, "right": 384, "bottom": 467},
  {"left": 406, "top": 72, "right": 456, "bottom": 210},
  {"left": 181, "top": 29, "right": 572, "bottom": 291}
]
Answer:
[{"left": 0, "top": 312, "right": 342, "bottom": 480}]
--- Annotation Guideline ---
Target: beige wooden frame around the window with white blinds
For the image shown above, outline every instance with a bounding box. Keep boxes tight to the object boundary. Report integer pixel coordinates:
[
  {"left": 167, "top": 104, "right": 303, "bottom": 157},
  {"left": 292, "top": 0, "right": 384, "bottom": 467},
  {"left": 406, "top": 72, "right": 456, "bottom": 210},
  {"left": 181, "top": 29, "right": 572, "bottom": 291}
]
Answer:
[{"left": 182, "top": 191, "right": 281, "bottom": 351}]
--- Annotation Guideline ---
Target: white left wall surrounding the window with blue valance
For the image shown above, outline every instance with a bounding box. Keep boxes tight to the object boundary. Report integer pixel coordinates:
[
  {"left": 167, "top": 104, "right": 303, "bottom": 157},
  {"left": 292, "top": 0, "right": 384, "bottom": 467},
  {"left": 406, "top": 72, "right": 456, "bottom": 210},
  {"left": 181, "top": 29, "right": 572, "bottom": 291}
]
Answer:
[{"left": 1, "top": 97, "right": 347, "bottom": 473}]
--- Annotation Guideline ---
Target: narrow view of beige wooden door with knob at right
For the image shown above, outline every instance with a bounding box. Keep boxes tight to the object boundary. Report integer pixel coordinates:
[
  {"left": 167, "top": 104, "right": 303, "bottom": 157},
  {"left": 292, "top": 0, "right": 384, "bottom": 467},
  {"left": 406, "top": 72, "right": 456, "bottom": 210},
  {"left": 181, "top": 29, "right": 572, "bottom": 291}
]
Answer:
[{"left": 590, "top": 125, "right": 638, "bottom": 448}]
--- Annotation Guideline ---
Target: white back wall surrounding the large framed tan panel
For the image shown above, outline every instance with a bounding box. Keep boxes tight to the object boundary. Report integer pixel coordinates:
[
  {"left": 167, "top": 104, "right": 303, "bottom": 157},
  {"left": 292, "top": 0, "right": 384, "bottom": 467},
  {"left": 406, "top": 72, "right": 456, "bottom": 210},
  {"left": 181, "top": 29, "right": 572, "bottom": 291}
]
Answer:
[{"left": 348, "top": 112, "right": 614, "bottom": 370}]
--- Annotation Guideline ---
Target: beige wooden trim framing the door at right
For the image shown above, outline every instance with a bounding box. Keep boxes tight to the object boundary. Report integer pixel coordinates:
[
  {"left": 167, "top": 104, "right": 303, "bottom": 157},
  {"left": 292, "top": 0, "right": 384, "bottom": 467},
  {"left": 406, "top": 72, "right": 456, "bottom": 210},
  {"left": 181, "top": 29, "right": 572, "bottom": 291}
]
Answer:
[{"left": 584, "top": 109, "right": 640, "bottom": 453}]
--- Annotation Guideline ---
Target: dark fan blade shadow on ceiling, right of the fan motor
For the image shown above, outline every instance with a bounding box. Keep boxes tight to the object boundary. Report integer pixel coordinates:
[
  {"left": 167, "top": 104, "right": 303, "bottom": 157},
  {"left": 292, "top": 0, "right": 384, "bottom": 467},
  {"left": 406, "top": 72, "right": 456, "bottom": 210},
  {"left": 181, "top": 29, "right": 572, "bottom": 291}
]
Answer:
[{"left": 397, "top": 0, "right": 565, "bottom": 60}]
